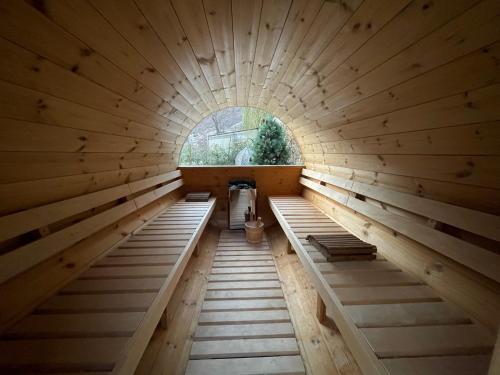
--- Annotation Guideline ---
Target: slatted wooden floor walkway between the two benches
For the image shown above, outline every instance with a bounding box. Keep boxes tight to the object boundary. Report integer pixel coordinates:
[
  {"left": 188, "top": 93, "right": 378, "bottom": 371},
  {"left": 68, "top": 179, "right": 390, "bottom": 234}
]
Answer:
[{"left": 186, "top": 231, "right": 305, "bottom": 375}]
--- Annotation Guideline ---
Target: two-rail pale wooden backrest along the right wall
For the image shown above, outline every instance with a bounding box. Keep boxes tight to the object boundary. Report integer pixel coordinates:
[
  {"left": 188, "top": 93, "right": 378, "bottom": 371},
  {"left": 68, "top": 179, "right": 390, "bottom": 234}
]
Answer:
[{"left": 300, "top": 169, "right": 500, "bottom": 282}]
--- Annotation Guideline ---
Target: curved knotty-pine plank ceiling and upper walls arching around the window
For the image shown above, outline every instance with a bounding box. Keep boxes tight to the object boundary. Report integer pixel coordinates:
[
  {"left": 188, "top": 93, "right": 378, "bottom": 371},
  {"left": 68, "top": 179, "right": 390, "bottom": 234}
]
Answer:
[{"left": 0, "top": 0, "right": 500, "bottom": 216}]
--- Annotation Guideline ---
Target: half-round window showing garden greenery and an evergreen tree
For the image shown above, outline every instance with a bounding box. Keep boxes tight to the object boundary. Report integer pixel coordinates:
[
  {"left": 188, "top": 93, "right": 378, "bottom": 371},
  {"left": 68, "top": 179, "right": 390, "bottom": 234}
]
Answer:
[{"left": 179, "top": 107, "right": 302, "bottom": 165}]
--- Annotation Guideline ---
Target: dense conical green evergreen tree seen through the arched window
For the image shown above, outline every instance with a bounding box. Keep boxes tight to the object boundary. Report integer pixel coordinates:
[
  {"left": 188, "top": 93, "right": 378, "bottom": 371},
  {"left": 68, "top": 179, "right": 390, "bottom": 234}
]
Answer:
[{"left": 252, "top": 116, "right": 290, "bottom": 165}]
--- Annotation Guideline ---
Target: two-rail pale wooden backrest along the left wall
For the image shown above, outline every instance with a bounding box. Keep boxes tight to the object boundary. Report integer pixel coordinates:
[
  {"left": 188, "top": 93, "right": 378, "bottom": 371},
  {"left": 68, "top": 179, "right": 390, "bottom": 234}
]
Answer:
[{"left": 0, "top": 170, "right": 184, "bottom": 283}]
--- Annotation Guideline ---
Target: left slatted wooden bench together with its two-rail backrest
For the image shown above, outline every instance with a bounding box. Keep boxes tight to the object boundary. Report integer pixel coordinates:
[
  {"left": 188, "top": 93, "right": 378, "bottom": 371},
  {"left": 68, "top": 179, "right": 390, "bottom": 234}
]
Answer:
[{"left": 0, "top": 171, "right": 215, "bottom": 374}]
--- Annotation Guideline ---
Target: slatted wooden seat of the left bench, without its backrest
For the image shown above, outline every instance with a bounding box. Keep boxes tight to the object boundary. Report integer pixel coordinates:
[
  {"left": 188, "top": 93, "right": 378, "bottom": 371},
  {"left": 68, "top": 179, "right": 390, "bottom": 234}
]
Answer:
[{"left": 0, "top": 200, "right": 215, "bottom": 374}]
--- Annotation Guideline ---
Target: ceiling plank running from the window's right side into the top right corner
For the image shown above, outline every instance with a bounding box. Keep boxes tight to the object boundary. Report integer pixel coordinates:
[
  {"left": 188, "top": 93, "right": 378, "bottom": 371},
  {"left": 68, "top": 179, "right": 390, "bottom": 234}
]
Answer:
[{"left": 300, "top": 0, "right": 500, "bottom": 123}]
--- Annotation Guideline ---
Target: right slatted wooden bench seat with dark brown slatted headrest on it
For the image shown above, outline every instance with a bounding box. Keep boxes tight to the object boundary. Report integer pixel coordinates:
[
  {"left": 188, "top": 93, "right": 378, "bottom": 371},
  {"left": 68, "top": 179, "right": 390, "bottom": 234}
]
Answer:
[{"left": 269, "top": 195, "right": 495, "bottom": 375}]
